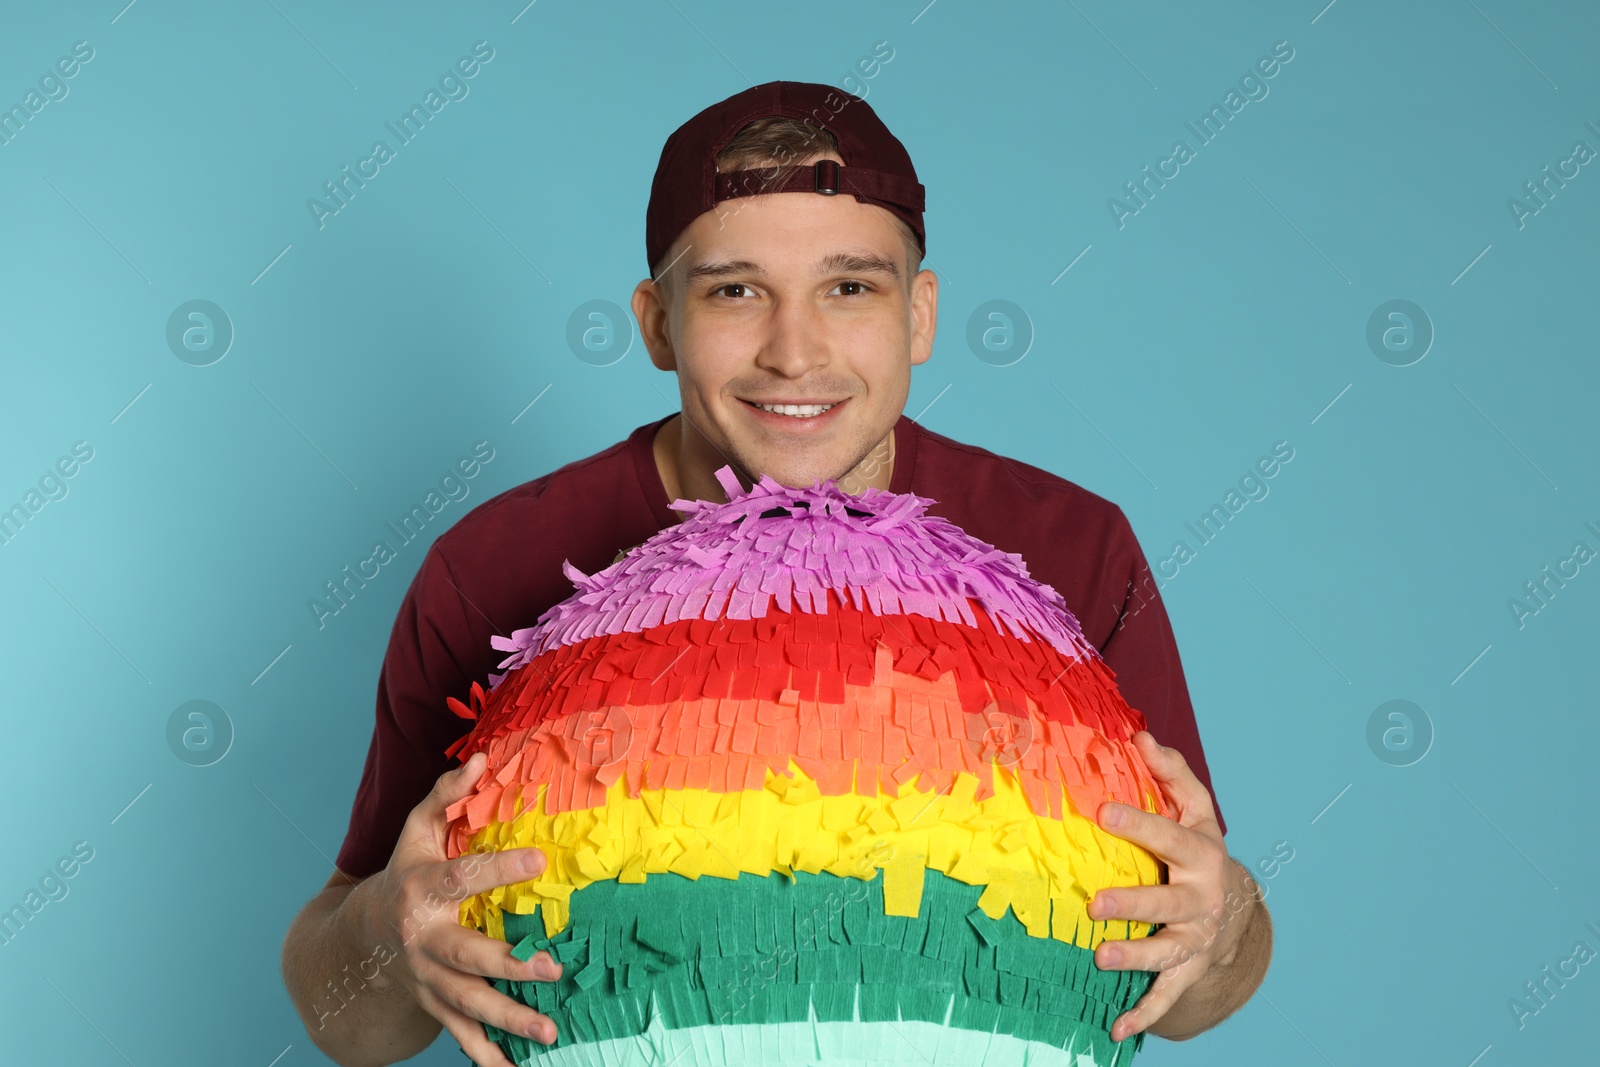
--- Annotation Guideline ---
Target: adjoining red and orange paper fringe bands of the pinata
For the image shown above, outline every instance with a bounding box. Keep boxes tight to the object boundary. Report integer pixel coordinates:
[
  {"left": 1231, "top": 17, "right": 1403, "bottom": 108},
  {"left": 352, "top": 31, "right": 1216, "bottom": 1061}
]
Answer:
[{"left": 448, "top": 593, "right": 1166, "bottom": 831}]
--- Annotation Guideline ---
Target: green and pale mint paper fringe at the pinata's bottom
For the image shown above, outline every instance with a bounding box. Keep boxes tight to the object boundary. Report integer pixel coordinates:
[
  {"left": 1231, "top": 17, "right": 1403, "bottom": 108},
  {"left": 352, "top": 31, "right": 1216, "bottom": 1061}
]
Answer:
[{"left": 485, "top": 869, "right": 1158, "bottom": 1067}]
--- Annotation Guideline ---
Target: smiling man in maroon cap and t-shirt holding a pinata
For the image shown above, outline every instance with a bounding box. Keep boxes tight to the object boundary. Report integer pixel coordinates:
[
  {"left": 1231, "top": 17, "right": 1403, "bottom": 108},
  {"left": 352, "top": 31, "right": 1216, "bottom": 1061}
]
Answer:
[{"left": 283, "top": 82, "right": 1272, "bottom": 1067}]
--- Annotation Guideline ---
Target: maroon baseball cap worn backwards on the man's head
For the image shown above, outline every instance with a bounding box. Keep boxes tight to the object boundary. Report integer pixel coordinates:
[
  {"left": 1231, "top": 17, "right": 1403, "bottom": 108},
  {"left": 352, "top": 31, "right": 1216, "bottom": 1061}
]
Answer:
[{"left": 645, "top": 82, "right": 928, "bottom": 278}]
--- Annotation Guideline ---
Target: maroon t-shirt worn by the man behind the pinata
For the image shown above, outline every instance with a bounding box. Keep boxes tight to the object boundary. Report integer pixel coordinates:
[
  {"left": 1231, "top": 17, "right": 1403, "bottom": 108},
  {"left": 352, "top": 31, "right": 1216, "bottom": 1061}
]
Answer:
[{"left": 336, "top": 414, "right": 1227, "bottom": 877}]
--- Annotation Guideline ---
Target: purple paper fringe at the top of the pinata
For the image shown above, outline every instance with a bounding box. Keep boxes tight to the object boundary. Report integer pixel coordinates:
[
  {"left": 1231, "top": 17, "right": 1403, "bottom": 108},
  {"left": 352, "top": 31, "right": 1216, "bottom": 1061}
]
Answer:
[{"left": 491, "top": 467, "right": 1098, "bottom": 685}]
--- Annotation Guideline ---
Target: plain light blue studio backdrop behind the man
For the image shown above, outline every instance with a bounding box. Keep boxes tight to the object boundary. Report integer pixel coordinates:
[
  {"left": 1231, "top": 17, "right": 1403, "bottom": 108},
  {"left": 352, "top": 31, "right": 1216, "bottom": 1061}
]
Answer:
[{"left": 0, "top": 0, "right": 1600, "bottom": 1067}]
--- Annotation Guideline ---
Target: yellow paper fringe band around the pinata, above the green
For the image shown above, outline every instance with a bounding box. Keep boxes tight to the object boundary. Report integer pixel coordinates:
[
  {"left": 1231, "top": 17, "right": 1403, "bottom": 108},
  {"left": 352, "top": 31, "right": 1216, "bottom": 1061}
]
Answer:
[{"left": 461, "top": 763, "right": 1165, "bottom": 950}]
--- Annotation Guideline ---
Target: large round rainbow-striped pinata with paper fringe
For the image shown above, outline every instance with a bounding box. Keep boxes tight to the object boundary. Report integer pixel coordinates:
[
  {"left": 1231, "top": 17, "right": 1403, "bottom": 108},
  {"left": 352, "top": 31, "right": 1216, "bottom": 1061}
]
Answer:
[{"left": 448, "top": 467, "right": 1170, "bottom": 1067}]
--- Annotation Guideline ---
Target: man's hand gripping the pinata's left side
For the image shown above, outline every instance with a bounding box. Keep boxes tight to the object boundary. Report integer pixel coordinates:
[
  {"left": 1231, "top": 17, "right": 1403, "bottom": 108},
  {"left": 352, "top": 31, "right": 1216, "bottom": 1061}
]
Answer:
[{"left": 352, "top": 752, "right": 562, "bottom": 1067}]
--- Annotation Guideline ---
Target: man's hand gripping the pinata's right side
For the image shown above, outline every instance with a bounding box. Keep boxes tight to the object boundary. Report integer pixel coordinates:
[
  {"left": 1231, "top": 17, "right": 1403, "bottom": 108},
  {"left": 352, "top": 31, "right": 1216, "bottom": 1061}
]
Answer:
[{"left": 1088, "top": 729, "right": 1259, "bottom": 1041}]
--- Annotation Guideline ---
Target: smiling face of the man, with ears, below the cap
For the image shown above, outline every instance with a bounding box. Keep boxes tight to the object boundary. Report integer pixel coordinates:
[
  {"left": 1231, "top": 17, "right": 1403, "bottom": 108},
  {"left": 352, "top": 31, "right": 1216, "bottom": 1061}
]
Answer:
[{"left": 634, "top": 157, "right": 938, "bottom": 486}]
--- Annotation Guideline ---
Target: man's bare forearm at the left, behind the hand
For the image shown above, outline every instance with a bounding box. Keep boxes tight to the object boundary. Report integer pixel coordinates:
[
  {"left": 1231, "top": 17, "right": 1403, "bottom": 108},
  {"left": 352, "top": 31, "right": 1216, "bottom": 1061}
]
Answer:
[{"left": 283, "top": 881, "right": 442, "bottom": 1067}]
